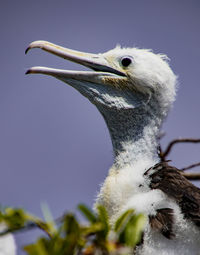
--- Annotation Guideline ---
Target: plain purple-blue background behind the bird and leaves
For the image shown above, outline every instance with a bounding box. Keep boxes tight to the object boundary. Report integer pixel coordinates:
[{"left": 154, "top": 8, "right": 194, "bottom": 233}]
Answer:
[{"left": 0, "top": 0, "right": 200, "bottom": 253}]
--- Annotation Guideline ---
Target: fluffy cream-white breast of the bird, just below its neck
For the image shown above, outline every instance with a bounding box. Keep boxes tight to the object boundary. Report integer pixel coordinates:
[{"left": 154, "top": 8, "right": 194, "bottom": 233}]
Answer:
[{"left": 96, "top": 164, "right": 162, "bottom": 223}]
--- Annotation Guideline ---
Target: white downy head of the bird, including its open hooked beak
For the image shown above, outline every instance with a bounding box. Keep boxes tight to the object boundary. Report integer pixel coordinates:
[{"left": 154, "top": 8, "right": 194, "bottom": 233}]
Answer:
[{"left": 26, "top": 41, "right": 176, "bottom": 114}]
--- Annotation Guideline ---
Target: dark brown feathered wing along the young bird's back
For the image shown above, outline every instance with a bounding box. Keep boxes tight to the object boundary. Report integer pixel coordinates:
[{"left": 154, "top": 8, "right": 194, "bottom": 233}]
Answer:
[{"left": 145, "top": 162, "right": 200, "bottom": 227}]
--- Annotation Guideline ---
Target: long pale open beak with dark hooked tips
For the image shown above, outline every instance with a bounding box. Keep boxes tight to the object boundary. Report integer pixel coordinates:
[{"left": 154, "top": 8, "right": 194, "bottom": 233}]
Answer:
[{"left": 25, "top": 41, "right": 126, "bottom": 84}]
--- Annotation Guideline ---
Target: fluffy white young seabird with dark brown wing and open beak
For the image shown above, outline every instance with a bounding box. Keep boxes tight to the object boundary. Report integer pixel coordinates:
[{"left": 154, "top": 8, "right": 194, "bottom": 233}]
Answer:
[{"left": 26, "top": 41, "right": 200, "bottom": 255}]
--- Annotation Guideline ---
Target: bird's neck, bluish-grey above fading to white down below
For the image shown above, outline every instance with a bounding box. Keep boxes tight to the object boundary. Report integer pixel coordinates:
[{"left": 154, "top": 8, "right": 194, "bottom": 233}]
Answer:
[{"left": 99, "top": 102, "right": 162, "bottom": 169}]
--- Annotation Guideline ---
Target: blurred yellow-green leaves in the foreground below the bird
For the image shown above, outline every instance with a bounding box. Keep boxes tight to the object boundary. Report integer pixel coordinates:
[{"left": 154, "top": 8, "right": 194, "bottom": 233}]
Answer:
[{"left": 0, "top": 204, "right": 146, "bottom": 255}]
